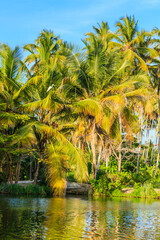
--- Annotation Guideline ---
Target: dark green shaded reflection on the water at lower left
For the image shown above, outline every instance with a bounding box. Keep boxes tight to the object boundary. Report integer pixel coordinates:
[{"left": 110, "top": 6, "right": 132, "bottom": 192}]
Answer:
[{"left": 0, "top": 198, "right": 47, "bottom": 240}]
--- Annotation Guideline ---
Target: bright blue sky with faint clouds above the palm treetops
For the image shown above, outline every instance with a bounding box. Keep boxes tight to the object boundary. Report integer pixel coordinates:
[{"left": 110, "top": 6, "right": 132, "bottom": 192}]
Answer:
[{"left": 0, "top": 0, "right": 160, "bottom": 47}]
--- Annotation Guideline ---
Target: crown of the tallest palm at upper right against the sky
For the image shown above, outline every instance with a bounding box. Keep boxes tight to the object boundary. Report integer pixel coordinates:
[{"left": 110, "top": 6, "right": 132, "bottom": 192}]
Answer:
[{"left": 109, "top": 16, "right": 156, "bottom": 72}]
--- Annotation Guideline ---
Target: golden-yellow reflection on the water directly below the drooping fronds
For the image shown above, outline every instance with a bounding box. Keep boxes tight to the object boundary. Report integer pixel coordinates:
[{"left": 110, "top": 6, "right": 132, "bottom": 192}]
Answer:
[{"left": 45, "top": 198, "right": 87, "bottom": 239}]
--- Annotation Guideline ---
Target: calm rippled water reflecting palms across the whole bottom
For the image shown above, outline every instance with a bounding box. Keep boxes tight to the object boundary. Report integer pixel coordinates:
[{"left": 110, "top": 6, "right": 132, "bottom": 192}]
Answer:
[{"left": 0, "top": 196, "right": 160, "bottom": 240}]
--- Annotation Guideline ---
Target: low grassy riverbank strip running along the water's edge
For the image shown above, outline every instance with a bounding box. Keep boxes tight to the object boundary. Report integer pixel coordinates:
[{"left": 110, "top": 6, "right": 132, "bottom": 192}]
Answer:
[{"left": 0, "top": 181, "right": 160, "bottom": 199}]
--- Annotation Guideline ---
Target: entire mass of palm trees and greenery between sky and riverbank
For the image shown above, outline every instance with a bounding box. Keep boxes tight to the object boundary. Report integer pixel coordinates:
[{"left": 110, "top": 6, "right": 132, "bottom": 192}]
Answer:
[{"left": 0, "top": 16, "right": 160, "bottom": 195}]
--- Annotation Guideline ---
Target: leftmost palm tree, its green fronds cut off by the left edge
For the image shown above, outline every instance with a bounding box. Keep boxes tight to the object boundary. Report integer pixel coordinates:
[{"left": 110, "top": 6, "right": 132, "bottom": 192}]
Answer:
[{"left": 0, "top": 44, "right": 28, "bottom": 183}]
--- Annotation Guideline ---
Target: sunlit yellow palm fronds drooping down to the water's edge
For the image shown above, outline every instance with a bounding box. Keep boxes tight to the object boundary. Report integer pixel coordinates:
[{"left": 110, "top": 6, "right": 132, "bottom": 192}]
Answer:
[{"left": 46, "top": 137, "right": 88, "bottom": 195}]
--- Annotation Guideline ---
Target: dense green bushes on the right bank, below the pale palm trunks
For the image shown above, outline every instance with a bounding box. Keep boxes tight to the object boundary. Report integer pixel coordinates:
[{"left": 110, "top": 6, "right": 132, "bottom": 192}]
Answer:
[{"left": 90, "top": 165, "right": 160, "bottom": 198}]
